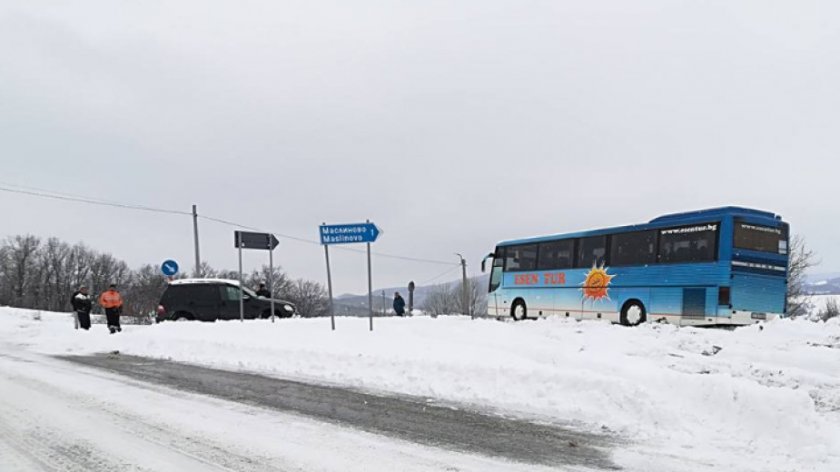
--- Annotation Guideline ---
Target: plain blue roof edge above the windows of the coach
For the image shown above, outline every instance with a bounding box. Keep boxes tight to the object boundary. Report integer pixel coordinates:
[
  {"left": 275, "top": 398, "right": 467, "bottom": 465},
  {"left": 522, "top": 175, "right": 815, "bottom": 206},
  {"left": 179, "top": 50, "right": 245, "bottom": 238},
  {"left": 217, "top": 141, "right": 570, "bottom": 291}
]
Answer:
[{"left": 498, "top": 206, "right": 782, "bottom": 246}]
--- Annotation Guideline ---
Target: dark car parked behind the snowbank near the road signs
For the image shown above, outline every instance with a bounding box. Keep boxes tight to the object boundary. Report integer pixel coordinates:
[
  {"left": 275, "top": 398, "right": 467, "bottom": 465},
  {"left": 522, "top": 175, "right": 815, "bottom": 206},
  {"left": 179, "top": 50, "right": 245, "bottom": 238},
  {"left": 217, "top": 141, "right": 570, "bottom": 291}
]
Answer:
[{"left": 157, "top": 279, "right": 295, "bottom": 322}]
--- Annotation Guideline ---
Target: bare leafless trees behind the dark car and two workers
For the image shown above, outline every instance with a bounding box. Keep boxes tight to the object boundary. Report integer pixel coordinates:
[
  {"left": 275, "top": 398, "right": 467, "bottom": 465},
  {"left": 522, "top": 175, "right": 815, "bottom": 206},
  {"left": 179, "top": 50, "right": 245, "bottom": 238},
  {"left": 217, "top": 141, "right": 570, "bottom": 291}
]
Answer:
[{"left": 0, "top": 234, "right": 329, "bottom": 316}]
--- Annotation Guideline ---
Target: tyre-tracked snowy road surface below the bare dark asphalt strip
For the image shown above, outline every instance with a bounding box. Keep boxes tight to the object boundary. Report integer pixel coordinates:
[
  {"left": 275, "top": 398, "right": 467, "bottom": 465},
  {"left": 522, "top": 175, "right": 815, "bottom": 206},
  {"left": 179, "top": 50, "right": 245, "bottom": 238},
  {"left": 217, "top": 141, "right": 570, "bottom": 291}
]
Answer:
[{"left": 0, "top": 342, "right": 540, "bottom": 472}]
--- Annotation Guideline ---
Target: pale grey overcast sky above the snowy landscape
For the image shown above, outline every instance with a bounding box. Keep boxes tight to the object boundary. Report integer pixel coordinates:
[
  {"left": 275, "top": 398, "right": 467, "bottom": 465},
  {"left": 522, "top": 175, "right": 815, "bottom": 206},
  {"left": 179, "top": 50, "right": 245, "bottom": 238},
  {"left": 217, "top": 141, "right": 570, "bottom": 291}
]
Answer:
[{"left": 0, "top": 0, "right": 840, "bottom": 293}]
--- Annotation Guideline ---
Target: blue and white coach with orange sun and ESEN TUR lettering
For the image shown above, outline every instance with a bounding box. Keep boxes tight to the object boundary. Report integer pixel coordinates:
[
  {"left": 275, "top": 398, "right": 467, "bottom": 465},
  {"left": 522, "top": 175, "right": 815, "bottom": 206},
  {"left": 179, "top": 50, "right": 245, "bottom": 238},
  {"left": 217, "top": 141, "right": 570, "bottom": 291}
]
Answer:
[{"left": 482, "top": 207, "right": 789, "bottom": 326}]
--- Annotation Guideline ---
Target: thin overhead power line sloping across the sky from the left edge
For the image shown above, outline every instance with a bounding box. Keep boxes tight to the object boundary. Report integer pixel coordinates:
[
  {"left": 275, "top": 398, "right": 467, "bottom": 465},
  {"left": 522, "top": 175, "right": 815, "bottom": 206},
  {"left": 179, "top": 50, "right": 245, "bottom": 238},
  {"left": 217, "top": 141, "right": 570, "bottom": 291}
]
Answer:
[{"left": 0, "top": 182, "right": 458, "bottom": 267}]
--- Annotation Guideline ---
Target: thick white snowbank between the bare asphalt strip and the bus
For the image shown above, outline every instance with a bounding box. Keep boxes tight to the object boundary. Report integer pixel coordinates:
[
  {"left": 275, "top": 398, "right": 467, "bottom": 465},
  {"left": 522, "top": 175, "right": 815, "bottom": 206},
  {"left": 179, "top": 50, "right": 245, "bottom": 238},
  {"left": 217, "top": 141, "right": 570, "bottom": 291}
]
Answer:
[{"left": 0, "top": 309, "right": 840, "bottom": 472}]
